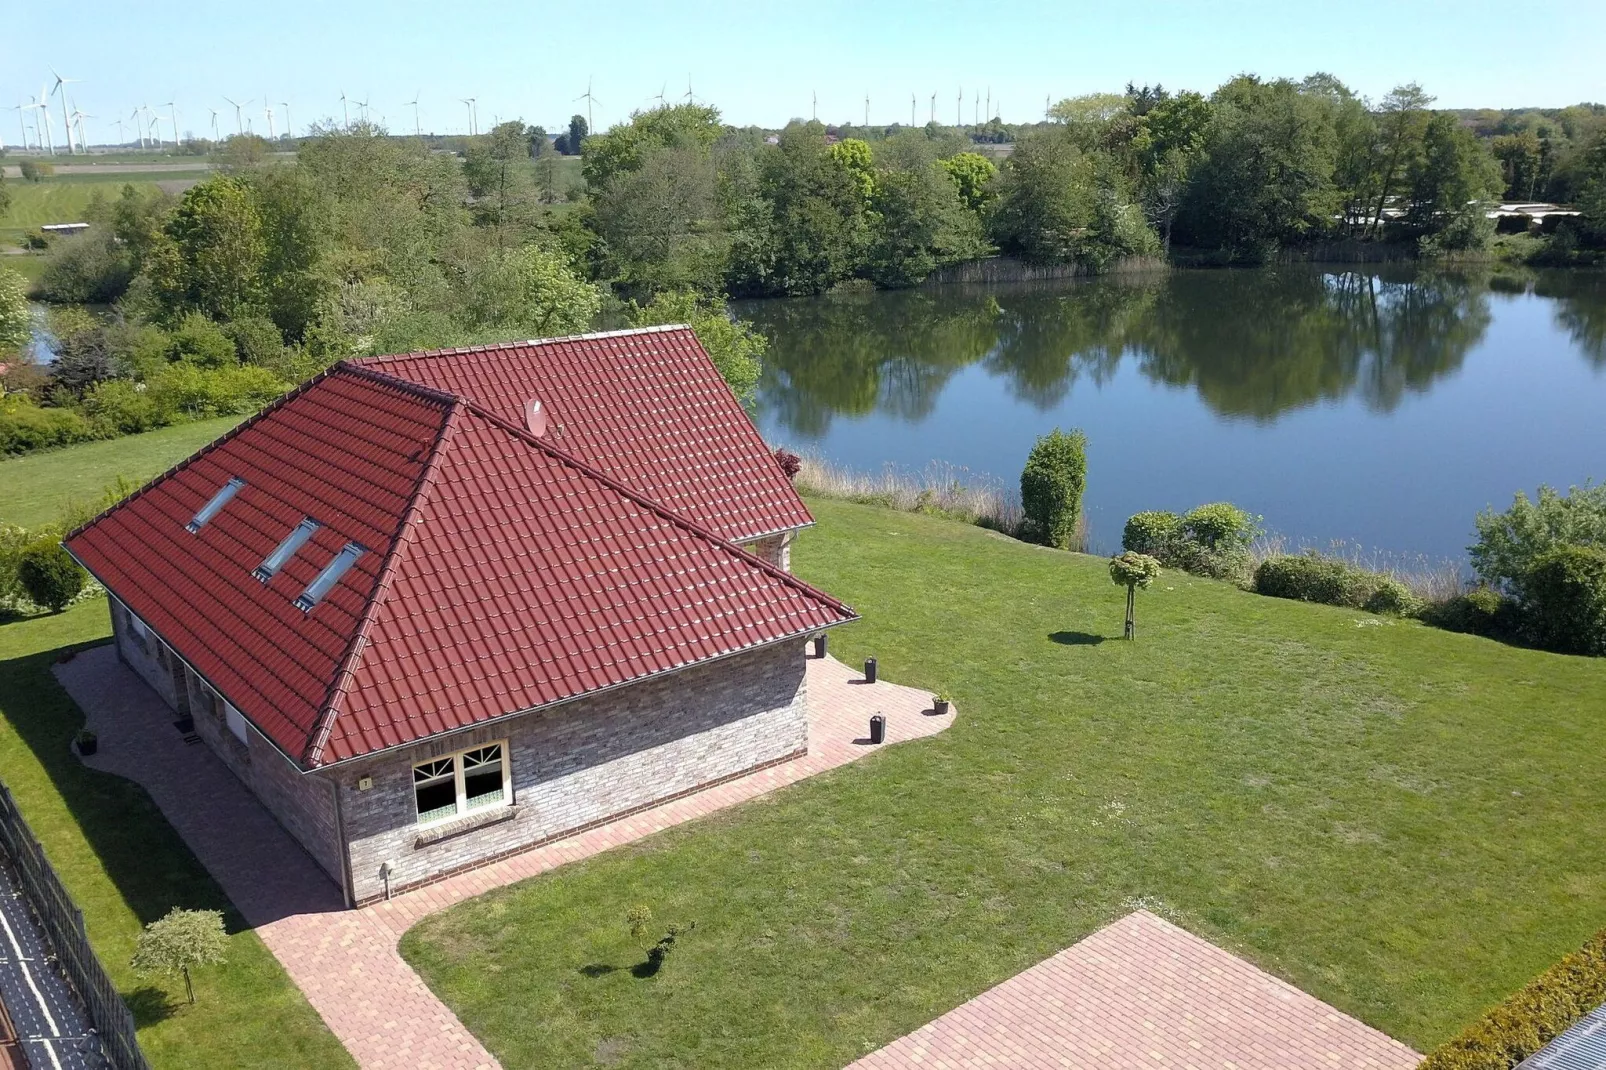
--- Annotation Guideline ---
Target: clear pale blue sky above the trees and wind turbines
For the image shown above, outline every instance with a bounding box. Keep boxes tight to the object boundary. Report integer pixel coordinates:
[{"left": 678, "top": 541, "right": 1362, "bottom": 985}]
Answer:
[{"left": 12, "top": 0, "right": 1606, "bottom": 145}]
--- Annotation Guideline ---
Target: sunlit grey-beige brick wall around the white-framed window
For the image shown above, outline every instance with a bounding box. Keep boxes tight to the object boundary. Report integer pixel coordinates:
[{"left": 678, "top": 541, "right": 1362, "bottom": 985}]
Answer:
[{"left": 340, "top": 639, "right": 808, "bottom": 903}]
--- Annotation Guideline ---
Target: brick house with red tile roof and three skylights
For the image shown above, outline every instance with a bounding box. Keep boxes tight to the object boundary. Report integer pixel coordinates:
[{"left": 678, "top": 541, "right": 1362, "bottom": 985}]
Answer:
[{"left": 66, "top": 328, "right": 854, "bottom": 905}]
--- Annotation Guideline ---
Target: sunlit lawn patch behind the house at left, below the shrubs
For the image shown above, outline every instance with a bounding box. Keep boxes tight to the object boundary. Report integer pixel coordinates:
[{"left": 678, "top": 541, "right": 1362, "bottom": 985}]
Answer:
[{"left": 0, "top": 416, "right": 241, "bottom": 527}]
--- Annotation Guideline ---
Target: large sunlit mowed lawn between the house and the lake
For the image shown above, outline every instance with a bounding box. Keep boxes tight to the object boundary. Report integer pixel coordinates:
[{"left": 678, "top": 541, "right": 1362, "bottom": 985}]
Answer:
[{"left": 402, "top": 501, "right": 1606, "bottom": 1068}]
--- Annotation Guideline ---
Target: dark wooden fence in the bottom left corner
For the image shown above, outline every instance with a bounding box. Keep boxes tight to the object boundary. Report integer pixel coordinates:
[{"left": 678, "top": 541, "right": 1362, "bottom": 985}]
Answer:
[{"left": 0, "top": 784, "right": 151, "bottom": 1070}]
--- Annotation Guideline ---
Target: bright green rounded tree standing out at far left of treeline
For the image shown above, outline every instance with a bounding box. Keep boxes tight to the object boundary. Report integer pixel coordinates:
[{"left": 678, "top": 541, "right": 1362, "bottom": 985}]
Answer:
[{"left": 149, "top": 175, "right": 267, "bottom": 320}]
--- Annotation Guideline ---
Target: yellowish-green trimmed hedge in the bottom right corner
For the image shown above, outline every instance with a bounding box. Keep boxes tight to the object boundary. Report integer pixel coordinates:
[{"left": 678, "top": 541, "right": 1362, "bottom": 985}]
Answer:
[{"left": 1418, "top": 930, "right": 1606, "bottom": 1070}]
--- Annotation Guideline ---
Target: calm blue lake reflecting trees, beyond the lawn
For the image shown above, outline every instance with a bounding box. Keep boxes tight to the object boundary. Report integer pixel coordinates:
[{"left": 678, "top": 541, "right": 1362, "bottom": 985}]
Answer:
[{"left": 736, "top": 265, "right": 1606, "bottom": 559}]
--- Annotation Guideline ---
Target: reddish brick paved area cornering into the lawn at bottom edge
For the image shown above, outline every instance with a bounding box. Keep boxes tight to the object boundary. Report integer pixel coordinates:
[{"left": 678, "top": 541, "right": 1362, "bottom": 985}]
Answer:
[{"left": 848, "top": 911, "right": 1421, "bottom": 1070}]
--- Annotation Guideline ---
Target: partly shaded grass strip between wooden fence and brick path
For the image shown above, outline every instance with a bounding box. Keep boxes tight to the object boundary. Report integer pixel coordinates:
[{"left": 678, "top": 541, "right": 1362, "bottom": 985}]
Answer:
[{"left": 0, "top": 594, "right": 353, "bottom": 1070}]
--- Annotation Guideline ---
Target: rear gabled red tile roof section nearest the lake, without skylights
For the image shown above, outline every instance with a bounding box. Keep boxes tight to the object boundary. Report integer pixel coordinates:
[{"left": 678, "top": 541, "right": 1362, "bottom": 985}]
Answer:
[{"left": 357, "top": 326, "right": 814, "bottom": 543}]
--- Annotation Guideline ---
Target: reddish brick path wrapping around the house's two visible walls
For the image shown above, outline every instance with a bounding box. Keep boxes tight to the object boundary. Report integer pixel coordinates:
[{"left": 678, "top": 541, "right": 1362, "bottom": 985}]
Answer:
[{"left": 56, "top": 644, "right": 952, "bottom": 1070}]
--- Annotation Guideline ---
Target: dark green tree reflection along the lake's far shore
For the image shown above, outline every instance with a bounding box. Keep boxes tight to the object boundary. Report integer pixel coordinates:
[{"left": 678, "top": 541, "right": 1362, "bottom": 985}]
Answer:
[{"left": 739, "top": 265, "right": 1606, "bottom": 439}]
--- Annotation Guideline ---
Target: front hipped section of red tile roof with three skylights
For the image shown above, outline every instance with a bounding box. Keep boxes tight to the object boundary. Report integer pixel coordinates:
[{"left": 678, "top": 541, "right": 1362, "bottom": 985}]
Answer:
[{"left": 67, "top": 348, "right": 853, "bottom": 770}]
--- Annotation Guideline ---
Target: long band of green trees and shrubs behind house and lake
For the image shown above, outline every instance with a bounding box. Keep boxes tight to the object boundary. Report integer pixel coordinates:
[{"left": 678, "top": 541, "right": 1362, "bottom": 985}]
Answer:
[{"left": 9, "top": 76, "right": 1606, "bottom": 451}]
